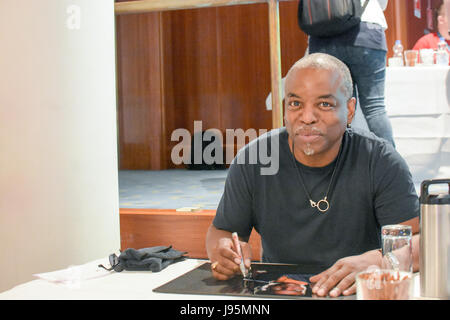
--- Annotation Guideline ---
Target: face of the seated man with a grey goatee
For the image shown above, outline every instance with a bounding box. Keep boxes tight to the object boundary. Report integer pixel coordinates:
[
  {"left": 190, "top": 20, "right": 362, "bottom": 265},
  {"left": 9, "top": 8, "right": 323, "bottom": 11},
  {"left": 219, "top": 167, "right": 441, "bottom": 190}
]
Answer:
[{"left": 285, "top": 68, "right": 355, "bottom": 166}]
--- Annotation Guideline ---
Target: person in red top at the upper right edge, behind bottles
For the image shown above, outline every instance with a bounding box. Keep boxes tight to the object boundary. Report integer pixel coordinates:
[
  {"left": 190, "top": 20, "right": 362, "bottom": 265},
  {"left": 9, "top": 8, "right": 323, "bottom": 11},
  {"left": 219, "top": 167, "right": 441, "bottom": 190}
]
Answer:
[{"left": 413, "top": 1, "right": 450, "bottom": 64}]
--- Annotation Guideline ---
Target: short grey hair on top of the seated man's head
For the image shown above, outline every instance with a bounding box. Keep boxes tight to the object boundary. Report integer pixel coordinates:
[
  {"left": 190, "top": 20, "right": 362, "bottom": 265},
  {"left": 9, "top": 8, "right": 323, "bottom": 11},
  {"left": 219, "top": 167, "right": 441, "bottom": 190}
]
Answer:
[{"left": 286, "top": 53, "right": 353, "bottom": 99}]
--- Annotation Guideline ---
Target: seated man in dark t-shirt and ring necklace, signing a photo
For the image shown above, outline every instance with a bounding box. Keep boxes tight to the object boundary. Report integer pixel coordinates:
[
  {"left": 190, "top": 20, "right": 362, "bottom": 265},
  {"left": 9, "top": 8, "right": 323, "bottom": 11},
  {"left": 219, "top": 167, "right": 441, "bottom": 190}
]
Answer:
[{"left": 206, "top": 54, "right": 419, "bottom": 296}]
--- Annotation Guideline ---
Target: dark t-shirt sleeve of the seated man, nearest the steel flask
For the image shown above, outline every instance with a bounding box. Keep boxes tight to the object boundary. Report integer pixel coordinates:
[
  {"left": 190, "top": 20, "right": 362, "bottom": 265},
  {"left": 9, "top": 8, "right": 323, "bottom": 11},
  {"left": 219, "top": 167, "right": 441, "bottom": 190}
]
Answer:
[{"left": 372, "top": 144, "right": 419, "bottom": 226}]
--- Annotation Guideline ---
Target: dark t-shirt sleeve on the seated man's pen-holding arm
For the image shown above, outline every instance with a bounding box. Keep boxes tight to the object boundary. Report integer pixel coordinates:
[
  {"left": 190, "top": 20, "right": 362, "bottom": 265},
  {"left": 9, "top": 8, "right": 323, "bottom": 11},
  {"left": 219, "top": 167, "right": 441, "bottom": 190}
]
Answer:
[{"left": 213, "top": 153, "right": 253, "bottom": 237}]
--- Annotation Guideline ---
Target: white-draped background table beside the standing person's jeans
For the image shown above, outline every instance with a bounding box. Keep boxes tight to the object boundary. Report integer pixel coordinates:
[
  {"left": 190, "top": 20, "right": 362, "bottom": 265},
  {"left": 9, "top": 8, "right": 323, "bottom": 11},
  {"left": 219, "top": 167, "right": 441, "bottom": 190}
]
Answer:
[{"left": 385, "top": 66, "right": 450, "bottom": 191}]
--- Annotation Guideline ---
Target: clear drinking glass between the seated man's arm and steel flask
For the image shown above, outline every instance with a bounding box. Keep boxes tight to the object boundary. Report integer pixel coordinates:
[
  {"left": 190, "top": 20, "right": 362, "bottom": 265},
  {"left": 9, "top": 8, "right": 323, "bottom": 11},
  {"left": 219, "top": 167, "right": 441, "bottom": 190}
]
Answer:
[{"left": 381, "top": 224, "right": 412, "bottom": 272}]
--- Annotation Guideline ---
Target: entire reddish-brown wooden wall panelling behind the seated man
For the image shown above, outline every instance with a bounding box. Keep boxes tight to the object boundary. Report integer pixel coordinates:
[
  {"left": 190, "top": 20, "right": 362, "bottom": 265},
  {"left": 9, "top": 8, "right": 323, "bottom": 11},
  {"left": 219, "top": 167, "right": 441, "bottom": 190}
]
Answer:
[{"left": 117, "top": 1, "right": 306, "bottom": 169}]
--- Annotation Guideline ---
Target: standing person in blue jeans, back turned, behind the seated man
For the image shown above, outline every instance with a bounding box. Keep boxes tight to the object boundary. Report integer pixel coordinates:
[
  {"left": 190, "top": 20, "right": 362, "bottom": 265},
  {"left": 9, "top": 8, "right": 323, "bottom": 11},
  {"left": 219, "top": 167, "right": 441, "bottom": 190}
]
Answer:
[{"left": 309, "top": 0, "right": 395, "bottom": 147}]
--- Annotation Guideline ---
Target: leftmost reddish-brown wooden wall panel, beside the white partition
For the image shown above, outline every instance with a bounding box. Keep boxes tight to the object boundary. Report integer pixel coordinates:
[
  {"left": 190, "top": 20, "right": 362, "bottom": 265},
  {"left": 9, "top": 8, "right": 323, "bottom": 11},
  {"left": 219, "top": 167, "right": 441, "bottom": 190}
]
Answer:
[{"left": 116, "top": 13, "right": 165, "bottom": 169}]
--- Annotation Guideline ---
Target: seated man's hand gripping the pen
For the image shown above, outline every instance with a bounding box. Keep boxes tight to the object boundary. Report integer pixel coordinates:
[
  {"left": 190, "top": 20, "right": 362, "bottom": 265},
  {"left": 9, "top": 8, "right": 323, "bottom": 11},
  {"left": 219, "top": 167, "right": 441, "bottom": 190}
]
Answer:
[{"left": 206, "top": 226, "right": 252, "bottom": 280}]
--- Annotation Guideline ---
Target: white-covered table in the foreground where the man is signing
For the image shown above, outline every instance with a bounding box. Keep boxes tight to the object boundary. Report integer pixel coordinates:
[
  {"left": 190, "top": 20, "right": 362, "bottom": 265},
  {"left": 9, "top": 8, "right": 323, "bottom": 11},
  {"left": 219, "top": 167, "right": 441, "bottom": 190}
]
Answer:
[{"left": 0, "top": 258, "right": 421, "bottom": 300}]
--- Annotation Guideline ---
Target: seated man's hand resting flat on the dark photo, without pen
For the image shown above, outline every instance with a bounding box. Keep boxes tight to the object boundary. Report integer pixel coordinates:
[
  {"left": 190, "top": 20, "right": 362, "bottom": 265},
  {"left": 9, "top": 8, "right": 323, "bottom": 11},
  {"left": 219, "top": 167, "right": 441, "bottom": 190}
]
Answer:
[{"left": 309, "top": 250, "right": 381, "bottom": 297}]
